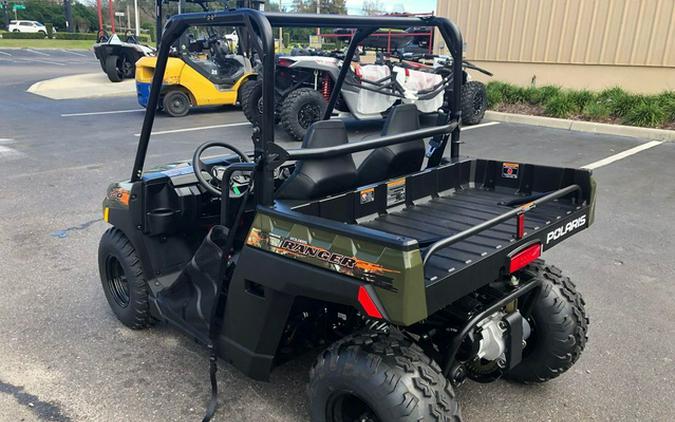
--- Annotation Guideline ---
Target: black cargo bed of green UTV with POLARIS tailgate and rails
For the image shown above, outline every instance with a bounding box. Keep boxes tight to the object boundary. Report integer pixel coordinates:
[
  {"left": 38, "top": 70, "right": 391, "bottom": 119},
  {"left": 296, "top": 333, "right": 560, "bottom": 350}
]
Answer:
[{"left": 282, "top": 158, "right": 594, "bottom": 313}]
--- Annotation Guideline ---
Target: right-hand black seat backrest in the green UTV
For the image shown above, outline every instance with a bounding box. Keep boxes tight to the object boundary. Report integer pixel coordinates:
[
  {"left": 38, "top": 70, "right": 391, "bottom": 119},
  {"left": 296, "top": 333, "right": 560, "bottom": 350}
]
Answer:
[{"left": 357, "top": 104, "right": 425, "bottom": 186}]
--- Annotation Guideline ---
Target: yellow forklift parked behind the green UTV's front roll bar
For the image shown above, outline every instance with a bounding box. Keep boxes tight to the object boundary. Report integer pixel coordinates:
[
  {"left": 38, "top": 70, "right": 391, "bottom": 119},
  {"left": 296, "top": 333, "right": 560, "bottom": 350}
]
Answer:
[{"left": 136, "top": 0, "right": 262, "bottom": 117}]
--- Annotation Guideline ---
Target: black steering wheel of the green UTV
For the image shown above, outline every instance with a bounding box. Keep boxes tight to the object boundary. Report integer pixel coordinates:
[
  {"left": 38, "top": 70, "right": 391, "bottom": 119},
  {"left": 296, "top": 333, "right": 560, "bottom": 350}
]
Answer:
[{"left": 192, "top": 142, "right": 251, "bottom": 197}]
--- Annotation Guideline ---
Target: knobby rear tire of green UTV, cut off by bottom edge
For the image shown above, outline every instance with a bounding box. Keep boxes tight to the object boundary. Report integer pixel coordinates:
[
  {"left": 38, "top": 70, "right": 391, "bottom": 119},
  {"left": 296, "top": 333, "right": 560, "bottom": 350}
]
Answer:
[{"left": 308, "top": 332, "right": 461, "bottom": 422}]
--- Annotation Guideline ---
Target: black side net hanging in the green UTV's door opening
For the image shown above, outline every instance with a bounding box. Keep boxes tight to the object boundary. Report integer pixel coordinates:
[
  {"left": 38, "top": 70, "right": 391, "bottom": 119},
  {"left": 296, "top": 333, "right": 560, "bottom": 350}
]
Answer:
[{"left": 157, "top": 226, "right": 228, "bottom": 344}]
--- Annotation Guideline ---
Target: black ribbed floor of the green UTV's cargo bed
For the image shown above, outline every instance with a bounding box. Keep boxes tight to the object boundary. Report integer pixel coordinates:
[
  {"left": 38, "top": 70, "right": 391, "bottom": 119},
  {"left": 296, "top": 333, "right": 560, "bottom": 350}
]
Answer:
[{"left": 361, "top": 188, "right": 577, "bottom": 283}]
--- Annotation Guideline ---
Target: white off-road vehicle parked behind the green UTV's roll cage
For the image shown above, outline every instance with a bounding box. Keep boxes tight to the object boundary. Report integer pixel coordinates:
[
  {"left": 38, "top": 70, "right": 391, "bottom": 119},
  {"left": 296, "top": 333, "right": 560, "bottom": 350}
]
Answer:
[{"left": 240, "top": 51, "right": 489, "bottom": 140}]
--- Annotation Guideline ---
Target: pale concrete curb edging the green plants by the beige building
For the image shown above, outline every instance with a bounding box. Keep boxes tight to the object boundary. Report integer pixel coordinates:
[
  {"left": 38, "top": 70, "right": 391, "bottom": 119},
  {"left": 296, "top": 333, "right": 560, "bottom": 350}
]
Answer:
[{"left": 485, "top": 111, "right": 675, "bottom": 142}]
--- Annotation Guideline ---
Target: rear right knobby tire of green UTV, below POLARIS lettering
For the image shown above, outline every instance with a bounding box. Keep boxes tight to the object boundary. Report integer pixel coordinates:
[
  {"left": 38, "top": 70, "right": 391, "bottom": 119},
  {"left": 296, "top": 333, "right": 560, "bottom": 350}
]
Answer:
[{"left": 505, "top": 260, "right": 588, "bottom": 383}]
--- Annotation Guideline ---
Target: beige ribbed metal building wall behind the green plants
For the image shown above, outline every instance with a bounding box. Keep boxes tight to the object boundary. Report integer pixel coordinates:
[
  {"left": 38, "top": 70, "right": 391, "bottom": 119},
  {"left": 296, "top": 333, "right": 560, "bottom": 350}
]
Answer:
[{"left": 436, "top": 0, "right": 675, "bottom": 93}]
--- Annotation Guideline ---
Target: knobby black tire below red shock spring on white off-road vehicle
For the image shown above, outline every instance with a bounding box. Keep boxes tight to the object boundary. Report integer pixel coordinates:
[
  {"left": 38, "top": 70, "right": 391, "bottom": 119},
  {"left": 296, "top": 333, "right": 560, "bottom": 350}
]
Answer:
[{"left": 281, "top": 88, "right": 327, "bottom": 141}]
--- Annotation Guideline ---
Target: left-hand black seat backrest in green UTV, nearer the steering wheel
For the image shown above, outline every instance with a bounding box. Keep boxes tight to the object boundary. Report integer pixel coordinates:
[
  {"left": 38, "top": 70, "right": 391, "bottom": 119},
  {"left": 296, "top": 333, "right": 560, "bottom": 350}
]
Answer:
[{"left": 277, "top": 120, "right": 356, "bottom": 200}]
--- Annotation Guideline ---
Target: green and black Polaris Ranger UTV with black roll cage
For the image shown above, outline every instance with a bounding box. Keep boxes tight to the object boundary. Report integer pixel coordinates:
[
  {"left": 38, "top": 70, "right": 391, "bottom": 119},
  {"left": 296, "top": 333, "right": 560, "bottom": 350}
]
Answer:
[{"left": 99, "top": 9, "right": 595, "bottom": 421}]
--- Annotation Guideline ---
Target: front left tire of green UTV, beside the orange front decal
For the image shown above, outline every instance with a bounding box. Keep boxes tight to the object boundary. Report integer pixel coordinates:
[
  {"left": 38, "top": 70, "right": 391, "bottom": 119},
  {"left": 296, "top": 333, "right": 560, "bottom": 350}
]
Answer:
[{"left": 98, "top": 228, "right": 150, "bottom": 330}]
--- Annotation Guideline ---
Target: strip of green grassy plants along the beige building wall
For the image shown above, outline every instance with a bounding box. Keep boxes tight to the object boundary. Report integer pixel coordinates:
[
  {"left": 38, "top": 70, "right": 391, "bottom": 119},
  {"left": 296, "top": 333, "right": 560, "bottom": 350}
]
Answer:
[{"left": 487, "top": 82, "right": 675, "bottom": 128}]
